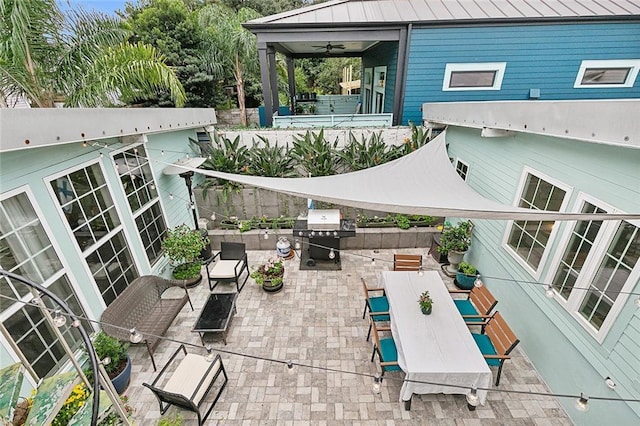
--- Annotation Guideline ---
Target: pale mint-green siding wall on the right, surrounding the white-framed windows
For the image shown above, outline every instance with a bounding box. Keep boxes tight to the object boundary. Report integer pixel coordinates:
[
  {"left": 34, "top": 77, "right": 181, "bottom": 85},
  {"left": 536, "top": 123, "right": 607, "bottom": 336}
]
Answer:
[{"left": 447, "top": 127, "right": 640, "bottom": 425}]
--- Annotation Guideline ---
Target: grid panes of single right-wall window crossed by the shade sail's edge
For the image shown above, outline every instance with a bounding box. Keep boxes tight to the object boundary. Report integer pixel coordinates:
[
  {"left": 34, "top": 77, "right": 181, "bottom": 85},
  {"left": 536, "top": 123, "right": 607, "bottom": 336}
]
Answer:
[{"left": 506, "top": 170, "right": 567, "bottom": 273}]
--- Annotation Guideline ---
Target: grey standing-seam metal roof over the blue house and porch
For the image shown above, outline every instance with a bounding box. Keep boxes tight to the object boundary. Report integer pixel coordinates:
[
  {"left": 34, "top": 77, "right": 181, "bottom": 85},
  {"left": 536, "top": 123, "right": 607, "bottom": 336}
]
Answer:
[{"left": 246, "top": 0, "right": 640, "bottom": 29}]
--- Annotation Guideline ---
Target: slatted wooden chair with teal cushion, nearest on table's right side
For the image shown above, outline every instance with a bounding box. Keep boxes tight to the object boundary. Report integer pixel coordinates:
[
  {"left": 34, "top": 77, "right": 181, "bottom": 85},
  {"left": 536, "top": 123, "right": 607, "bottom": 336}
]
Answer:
[{"left": 471, "top": 312, "right": 520, "bottom": 386}]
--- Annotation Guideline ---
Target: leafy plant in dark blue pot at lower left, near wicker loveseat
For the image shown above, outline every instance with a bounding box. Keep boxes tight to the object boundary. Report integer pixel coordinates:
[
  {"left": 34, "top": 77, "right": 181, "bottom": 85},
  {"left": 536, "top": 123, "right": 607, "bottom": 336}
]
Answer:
[{"left": 93, "top": 331, "right": 131, "bottom": 394}]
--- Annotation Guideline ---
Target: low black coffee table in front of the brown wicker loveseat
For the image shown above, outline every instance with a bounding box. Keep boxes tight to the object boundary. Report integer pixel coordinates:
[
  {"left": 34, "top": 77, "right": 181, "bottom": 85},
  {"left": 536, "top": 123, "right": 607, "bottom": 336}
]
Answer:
[{"left": 191, "top": 292, "right": 238, "bottom": 345}]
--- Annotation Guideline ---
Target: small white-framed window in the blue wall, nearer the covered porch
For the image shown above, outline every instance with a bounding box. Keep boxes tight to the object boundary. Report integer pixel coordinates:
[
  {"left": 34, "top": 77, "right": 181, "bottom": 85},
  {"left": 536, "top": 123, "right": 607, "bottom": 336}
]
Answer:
[{"left": 442, "top": 62, "right": 507, "bottom": 91}]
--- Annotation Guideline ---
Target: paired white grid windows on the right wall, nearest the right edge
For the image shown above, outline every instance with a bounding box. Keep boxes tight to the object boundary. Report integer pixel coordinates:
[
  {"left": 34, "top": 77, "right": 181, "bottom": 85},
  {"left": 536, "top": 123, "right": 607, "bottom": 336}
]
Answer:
[{"left": 551, "top": 199, "right": 640, "bottom": 340}]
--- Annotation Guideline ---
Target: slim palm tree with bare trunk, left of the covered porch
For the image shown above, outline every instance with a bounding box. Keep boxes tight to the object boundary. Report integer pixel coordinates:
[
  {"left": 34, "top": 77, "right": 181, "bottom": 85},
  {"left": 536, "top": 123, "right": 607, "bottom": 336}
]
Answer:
[{"left": 200, "top": 3, "right": 260, "bottom": 126}]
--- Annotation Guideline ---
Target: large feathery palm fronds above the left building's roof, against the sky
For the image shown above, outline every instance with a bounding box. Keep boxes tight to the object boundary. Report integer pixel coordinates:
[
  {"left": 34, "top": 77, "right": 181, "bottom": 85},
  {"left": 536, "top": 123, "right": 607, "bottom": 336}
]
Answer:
[{"left": 0, "top": 0, "right": 185, "bottom": 108}]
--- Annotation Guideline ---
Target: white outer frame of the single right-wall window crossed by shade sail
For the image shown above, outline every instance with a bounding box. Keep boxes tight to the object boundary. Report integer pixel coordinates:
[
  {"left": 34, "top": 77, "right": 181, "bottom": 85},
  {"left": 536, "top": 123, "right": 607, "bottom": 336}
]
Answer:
[{"left": 502, "top": 166, "right": 573, "bottom": 280}]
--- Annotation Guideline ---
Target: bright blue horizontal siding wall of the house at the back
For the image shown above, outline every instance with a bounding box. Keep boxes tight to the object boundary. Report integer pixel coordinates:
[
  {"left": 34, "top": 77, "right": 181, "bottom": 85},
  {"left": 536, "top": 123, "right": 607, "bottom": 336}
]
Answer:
[{"left": 403, "top": 22, "right": 640, "bottom": 124}]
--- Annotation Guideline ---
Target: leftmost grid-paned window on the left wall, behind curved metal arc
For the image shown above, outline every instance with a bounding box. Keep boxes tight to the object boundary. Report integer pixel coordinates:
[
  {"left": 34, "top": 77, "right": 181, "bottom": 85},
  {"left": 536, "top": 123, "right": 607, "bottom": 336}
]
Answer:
[{"left": 0, "top": 192, "right": 92, "bottom": 381}]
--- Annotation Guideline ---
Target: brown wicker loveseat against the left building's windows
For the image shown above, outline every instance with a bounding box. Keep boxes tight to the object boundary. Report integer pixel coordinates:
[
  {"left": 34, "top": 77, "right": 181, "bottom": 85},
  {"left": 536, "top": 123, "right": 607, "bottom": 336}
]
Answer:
[{"left": 100, "top": 275, "right": 193, "bottom": 371}]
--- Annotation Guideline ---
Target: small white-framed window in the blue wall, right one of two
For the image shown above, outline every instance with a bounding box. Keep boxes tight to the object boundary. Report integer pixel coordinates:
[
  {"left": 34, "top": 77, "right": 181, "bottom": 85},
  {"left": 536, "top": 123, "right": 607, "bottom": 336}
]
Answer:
[{"left": 574, "top": 59, "right": 640, "bottom": 88}]
